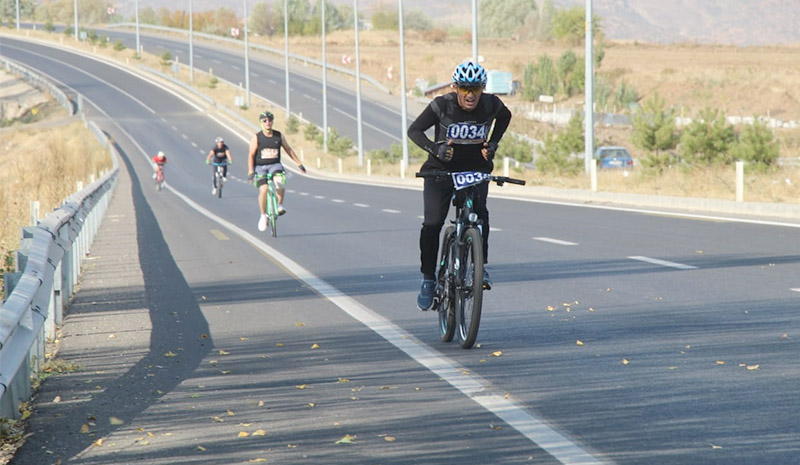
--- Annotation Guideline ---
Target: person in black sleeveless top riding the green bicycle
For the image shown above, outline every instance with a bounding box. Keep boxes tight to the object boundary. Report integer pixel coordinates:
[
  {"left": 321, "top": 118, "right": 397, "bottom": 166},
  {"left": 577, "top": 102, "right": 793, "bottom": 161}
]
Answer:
[{"left": 247, "top": 111, "right": 306, "bottom": 231}]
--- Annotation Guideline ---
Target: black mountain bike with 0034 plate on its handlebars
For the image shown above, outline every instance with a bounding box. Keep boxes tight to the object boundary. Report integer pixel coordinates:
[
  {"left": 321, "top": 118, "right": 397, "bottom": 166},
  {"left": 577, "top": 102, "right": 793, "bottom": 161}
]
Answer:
[{"left": 416, "top": 171, "right": 525, "bottom": 349}]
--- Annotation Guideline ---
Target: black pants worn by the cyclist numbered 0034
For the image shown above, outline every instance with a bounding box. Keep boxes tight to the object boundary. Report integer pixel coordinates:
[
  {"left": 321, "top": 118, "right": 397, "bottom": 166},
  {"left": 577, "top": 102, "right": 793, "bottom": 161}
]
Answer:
[{"left": 419, "top": 174, "right": 489, "bottom": 276}]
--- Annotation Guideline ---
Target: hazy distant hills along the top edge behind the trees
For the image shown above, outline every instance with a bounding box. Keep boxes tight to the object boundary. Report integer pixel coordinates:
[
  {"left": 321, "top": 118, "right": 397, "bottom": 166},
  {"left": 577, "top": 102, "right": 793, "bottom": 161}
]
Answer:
[{"left": 118, "top": 0, "right": 800, "bottom": 45}]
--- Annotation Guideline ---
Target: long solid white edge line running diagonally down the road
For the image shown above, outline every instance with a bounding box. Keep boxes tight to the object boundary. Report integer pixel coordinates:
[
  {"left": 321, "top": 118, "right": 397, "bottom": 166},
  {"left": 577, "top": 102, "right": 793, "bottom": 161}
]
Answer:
[{"left": 92, "top": 70, "right": 611, "bottom": 465}]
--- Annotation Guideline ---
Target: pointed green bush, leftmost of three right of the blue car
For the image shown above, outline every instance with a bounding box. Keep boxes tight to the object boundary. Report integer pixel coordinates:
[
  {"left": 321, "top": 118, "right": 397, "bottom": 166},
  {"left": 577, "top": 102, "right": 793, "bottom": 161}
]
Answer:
[{"left": 631, "top": 93, "right": 680, "bottom": 160}]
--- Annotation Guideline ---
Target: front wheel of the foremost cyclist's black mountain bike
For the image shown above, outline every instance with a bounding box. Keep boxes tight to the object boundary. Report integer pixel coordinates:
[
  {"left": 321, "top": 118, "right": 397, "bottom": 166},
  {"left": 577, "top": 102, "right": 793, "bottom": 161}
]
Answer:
[{"left": 456, "top": 228, "right": 483, "bottom": 349}]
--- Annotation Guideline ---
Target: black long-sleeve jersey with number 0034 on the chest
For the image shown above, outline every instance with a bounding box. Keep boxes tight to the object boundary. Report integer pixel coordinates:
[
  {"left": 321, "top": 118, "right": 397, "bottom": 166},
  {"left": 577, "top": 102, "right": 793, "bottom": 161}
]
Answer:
[{"left": 408, "top": 92, "right": 511, "bottom": 173}]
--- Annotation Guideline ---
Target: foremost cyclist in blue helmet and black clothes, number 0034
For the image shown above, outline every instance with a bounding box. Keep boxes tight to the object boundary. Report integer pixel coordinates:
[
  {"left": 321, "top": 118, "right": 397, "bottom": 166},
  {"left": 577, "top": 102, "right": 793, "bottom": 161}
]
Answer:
[{"left": 408, "top": 61, "right": 511, "bottom": 310}]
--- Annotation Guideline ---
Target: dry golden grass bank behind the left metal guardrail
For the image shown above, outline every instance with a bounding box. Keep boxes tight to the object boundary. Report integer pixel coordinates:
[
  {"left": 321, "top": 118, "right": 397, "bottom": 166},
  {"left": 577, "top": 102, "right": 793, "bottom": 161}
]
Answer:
[{"left": 0, "top": 121, "right": 111, "bottom": 274}]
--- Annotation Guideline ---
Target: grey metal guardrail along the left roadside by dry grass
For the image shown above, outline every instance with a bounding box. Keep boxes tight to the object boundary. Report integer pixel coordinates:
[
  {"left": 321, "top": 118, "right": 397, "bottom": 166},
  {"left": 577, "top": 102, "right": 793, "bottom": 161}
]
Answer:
[{"left": 0, "top": 79, "right": 119, "bottom": 418}]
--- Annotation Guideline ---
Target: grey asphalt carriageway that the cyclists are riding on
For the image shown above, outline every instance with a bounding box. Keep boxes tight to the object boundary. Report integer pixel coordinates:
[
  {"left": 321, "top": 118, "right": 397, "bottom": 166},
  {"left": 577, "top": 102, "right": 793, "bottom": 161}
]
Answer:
[{"left": 1, "top": 38, "right": 800, "bottom": 465}]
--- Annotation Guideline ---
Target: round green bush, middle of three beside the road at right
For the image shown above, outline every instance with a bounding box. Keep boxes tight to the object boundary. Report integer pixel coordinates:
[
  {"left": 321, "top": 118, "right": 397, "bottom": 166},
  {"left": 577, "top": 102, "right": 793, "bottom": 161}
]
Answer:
[{"left": 680, "top": 108, "right": 736, "bottom": 165}]
